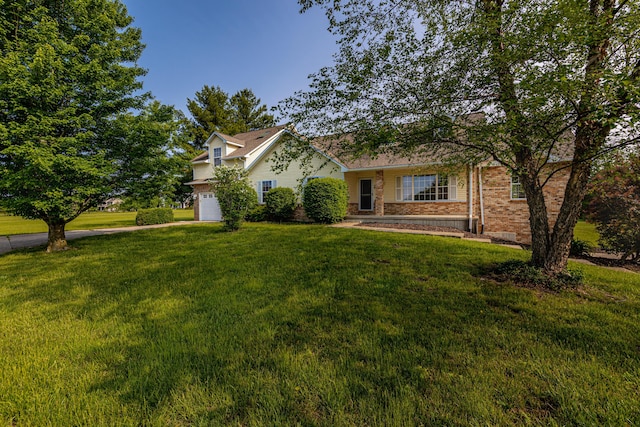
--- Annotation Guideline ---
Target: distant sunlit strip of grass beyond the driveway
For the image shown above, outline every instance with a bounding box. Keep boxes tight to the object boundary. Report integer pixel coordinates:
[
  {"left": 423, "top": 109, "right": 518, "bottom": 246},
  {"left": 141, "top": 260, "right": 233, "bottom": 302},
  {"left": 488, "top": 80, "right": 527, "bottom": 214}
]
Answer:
[{"left": 0, "top": 209, "right": 193, "bottom": 236}]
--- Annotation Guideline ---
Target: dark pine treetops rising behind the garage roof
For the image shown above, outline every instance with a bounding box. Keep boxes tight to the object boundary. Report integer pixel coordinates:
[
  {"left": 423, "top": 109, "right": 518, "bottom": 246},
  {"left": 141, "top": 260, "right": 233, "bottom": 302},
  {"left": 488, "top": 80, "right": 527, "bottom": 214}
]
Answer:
[{"left": 187, "top": 85, "right": 275, "bottom": 150}]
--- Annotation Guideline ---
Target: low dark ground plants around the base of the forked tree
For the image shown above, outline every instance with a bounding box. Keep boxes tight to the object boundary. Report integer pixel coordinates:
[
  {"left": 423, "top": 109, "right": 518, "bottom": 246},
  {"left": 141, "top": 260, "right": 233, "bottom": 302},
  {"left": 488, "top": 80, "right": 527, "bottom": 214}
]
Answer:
[{"left": 494, "top": 260, "right": 584, "bottom": 291}]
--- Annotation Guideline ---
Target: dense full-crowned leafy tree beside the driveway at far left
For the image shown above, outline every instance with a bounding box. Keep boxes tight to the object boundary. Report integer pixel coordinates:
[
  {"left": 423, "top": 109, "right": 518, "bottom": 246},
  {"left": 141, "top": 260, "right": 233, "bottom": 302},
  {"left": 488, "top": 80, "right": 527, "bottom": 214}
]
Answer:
[{"left": 0, "top": 0, "right": 145, "bottom": 251}]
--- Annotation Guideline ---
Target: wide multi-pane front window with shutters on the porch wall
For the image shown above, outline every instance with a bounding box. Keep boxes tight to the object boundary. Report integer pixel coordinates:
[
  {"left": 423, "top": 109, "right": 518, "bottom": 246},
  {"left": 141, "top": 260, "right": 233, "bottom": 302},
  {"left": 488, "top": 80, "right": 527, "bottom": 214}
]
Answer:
[{"left": 396, "top": 175, "right": 457, "bottom": 202}]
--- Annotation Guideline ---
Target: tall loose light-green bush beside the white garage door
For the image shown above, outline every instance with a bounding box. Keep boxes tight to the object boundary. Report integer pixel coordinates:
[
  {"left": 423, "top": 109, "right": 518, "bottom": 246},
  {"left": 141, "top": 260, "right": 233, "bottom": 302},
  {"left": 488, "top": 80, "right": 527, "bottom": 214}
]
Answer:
[{"left": 210, "top": 165, "right": 258, "bottom": 231}]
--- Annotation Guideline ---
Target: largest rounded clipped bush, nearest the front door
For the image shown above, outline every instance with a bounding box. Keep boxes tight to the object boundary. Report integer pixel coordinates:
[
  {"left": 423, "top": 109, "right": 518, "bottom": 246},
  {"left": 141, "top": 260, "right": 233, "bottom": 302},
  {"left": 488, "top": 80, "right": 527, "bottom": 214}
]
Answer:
[{"left": 302, "top": 178, "right": 348, "bottom": 224}]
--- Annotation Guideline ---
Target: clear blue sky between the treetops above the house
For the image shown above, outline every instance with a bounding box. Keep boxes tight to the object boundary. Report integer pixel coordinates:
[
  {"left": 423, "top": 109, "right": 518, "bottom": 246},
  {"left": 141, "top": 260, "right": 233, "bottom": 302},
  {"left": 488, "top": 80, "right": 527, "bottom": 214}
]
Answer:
[{"left": 122, "top": 0, "right": 337, "bottom": 121}]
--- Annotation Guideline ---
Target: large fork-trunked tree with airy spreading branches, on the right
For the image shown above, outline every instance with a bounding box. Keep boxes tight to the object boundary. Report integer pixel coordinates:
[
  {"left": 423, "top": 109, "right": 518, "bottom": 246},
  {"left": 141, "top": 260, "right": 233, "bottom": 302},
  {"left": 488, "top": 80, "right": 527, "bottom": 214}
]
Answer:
[{"left": 280, "top": 0, "right": 640, "bottom": 275}]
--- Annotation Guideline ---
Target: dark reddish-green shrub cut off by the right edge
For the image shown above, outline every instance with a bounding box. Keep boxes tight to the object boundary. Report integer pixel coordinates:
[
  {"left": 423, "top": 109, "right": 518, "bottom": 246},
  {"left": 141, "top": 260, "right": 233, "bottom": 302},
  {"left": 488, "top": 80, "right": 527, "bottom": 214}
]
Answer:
[{"left": 587, "top": 154, "right": 640, "bottom": 260}]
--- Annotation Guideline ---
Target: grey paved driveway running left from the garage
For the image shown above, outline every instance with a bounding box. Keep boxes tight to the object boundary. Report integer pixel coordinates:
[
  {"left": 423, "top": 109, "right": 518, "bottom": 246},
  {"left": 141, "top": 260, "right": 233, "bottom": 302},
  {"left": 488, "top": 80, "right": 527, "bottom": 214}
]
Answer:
[{"left": 0, "top": 221, "right": 202, "bottom": 255}]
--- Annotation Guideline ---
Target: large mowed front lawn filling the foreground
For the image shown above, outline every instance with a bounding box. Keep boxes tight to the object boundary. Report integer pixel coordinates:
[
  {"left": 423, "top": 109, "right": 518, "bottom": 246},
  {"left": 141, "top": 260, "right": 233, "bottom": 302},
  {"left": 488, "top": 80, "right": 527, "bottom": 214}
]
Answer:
[{"left": 0, "top": 224, "right": 640, "bottom": 426}]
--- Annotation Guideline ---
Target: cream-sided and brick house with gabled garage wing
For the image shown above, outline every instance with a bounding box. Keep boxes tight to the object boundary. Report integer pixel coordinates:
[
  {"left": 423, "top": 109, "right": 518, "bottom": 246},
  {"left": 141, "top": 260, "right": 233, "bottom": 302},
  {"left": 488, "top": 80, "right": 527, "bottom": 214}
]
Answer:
[{"left": 190, "top": 126, "right": 569, "bottom": 243}]
